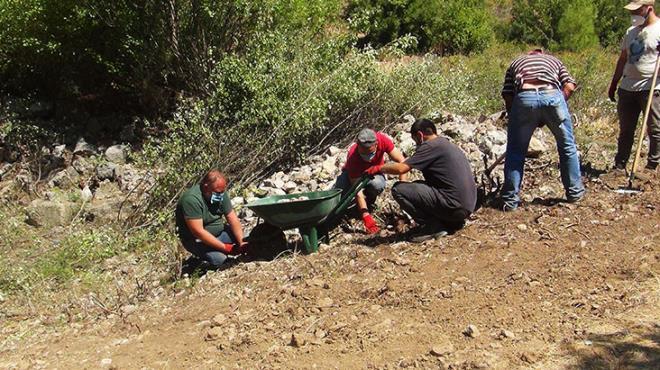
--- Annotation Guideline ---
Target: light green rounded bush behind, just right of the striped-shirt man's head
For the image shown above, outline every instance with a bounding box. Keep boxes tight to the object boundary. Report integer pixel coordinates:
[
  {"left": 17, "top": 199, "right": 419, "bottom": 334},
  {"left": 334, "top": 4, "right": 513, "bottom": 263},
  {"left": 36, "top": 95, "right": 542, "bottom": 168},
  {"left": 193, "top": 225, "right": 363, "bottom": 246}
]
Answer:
[{"left": 557, "top": 0, "right": 598, "bottom": 51}]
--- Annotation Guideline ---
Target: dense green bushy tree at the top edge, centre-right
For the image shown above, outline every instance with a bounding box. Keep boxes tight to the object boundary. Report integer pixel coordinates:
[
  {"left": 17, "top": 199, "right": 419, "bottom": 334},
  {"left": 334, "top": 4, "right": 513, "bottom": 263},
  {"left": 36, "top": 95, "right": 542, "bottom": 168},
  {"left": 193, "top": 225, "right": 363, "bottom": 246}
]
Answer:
[{"left": 347, "top": 0, "right": 493, "bottom": 54}]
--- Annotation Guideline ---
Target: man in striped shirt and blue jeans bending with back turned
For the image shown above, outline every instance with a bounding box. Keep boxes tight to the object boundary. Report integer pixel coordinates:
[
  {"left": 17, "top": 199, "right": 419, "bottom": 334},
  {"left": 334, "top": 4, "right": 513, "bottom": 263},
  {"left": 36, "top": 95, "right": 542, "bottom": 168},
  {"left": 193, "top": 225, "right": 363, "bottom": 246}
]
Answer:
[{"left": 501, "top": 49, "right": 585, "bottom": 211}]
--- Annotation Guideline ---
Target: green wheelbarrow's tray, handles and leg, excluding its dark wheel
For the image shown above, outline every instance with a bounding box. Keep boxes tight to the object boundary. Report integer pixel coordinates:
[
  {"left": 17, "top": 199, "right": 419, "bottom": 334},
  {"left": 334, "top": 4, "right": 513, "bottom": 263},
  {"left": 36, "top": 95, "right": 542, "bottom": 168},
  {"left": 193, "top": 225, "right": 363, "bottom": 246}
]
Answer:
[{"left": 247, "top": 175, "right": 371, "bottom": 253}]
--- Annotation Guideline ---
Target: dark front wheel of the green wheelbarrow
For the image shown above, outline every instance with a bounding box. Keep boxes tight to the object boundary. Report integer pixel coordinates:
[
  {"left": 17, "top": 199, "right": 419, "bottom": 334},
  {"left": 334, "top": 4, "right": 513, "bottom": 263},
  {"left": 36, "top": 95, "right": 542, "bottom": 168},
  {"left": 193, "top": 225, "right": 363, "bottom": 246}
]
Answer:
[{"left": 247, "top": 223, "right": 291, "bottom": 261}]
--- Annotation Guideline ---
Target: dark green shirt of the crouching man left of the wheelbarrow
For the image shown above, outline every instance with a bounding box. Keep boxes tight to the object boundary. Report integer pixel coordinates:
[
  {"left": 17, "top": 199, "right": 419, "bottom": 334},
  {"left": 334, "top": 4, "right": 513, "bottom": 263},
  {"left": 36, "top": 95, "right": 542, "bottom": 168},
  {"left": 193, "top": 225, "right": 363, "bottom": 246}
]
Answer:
[{"left": 176, "top": 184, "right": 232, "bottom": 240}]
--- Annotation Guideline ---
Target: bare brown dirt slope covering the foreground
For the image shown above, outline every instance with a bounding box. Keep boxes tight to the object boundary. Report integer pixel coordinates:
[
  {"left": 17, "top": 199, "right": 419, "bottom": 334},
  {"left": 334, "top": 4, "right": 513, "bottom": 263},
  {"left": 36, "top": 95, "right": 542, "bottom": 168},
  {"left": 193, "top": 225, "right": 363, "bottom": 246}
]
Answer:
[{"left": 0, "top": 171, "right": 660, "bottom": 369}]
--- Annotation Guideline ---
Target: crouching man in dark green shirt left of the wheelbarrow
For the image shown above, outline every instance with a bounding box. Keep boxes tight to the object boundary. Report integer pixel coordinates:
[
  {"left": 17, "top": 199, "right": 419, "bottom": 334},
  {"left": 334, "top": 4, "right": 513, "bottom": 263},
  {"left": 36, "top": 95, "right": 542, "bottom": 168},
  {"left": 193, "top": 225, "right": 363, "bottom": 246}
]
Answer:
[{"left": 176, "top": 169, "right": 247, "bottom": 269}]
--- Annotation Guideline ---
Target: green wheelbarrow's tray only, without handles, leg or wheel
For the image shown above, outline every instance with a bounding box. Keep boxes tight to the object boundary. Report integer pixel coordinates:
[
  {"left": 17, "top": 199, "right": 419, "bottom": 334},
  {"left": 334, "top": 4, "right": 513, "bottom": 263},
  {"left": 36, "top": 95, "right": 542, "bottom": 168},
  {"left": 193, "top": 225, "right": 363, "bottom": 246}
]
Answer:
[{"left": 247, "top": 189, "right": 342, "bottom": 230}]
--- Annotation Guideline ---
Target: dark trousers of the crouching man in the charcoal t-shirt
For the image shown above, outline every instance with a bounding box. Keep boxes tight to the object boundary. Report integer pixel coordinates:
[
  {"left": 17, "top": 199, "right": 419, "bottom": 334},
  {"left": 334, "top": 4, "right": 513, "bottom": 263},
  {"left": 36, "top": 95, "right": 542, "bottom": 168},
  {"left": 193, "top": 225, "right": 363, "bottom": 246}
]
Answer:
[{"left": 392, "top": 181, "right": 470, "bottom": 230}]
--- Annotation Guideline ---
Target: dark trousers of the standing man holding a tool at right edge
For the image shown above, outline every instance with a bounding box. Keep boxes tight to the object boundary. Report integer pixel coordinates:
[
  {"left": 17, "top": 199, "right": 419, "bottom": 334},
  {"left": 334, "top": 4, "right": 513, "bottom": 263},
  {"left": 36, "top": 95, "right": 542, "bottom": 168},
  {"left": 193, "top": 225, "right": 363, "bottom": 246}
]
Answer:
[{"left": 614, "top": 89, "right": 660, "bottom": 167}]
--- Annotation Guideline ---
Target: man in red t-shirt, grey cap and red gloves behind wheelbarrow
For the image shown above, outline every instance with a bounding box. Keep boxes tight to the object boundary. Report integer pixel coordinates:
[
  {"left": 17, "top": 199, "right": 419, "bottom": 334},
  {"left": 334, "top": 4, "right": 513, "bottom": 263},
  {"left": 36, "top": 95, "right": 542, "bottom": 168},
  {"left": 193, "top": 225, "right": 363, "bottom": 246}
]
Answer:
[{"left": 334, "top": 128, "right": 406, "bottom": 234}]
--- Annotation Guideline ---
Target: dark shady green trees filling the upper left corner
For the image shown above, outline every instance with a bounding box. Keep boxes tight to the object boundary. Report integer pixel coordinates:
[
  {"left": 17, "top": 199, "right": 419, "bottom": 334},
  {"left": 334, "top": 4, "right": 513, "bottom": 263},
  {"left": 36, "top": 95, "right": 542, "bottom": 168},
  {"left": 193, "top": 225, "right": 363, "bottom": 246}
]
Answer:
[{"left": 0, "top": 0, "right": 340, "bottom": 107}]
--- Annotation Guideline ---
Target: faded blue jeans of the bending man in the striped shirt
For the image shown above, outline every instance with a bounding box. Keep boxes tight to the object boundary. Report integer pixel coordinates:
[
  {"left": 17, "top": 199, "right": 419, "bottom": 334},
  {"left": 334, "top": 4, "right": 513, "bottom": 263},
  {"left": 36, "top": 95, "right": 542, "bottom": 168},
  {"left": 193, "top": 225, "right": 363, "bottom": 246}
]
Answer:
[{"left": 502, "top": 90, "right": 585, "bottom": 208}]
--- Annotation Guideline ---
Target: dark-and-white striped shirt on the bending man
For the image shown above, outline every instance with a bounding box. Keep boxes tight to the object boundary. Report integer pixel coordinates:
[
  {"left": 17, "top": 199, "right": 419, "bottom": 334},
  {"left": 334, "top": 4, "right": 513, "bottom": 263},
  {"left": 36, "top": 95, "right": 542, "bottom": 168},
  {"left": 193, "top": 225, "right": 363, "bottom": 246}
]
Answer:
[{"left": 502, "top": 54, "right": 575, "bottom": 95}]
